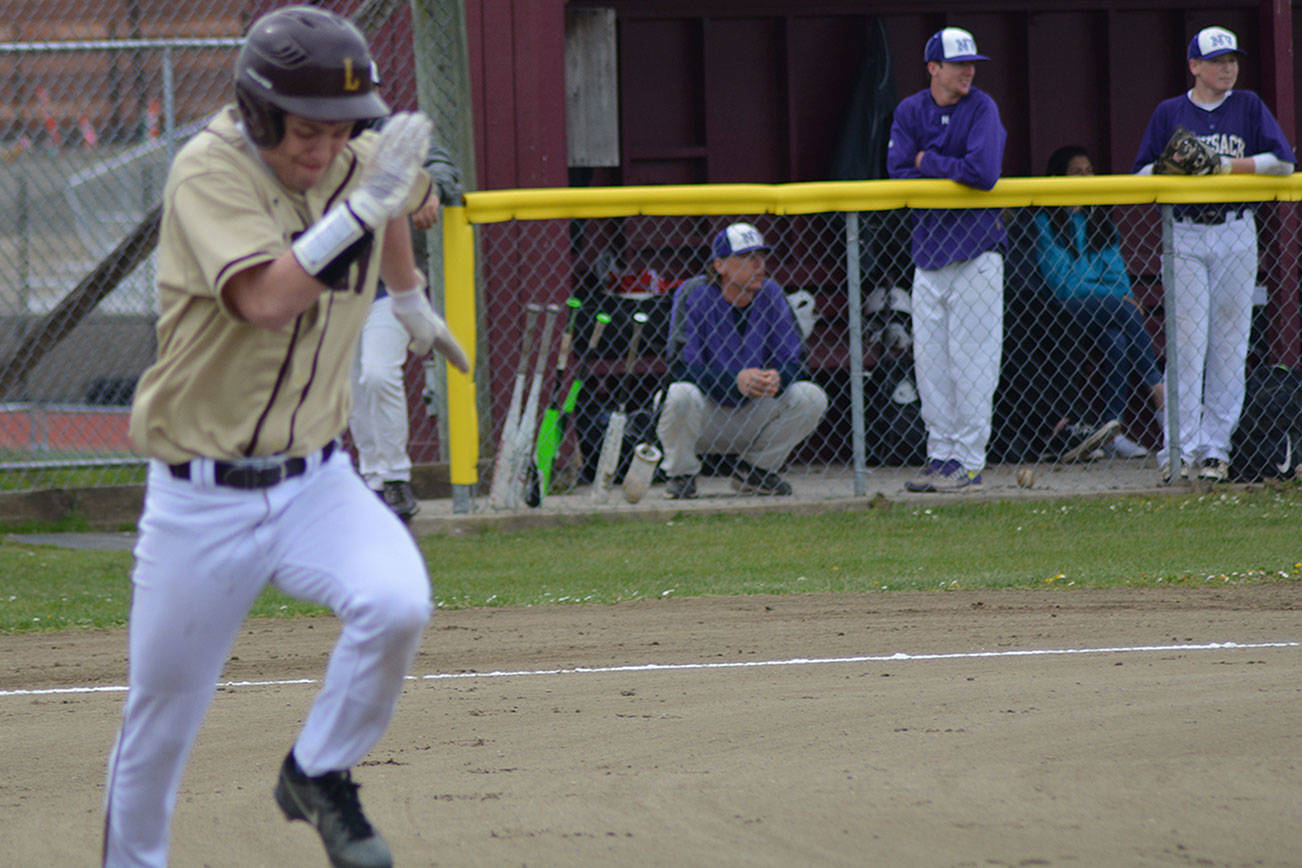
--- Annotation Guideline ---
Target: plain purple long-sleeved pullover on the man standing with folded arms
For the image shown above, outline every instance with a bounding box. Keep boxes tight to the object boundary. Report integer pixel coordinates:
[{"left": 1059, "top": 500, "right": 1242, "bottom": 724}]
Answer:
[{"left": 887, "top": 87, "right": 1008, "bottom": 269}]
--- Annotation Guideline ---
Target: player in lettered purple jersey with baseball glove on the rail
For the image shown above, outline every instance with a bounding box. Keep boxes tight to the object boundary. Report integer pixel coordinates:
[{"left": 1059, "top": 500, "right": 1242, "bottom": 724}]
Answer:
[{"left": 1134, "top": 27, "right": 1297, "bottom": 481}]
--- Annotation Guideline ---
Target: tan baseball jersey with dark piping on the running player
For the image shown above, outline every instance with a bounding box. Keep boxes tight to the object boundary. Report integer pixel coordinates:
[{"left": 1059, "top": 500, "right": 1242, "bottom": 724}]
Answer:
[{"left": 130, "top": 105, "right": 432, "bottom": 463}]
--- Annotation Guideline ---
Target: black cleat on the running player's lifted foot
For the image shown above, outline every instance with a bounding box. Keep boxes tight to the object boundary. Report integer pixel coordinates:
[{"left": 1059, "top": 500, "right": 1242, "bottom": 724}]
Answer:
[{"left": 276, "top": 751, "right": 393, "bottom": 868}]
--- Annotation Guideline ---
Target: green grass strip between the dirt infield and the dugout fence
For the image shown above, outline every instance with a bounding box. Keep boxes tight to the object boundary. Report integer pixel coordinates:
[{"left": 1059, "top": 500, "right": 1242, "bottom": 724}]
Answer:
[{"left": 0, "top": 485, "right": 1302, "bottom": 632}]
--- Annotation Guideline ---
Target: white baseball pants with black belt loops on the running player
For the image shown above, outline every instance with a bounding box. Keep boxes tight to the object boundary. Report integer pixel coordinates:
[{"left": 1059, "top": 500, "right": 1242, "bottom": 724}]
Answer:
[{"left": 104, "top": 449, "right": 431, "bottom": 868}]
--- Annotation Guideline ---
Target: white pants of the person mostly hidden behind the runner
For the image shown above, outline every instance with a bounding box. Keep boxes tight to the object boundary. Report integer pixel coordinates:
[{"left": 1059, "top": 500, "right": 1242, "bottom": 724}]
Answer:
[{"left": 348, "top": 295, "right": 411, "bottom": 491}]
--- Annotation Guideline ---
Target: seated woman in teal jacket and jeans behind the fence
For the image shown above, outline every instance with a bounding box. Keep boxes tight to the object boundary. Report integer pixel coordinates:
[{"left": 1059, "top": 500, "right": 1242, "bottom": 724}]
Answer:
[{"left": 1035, "top": 144, "right": 1163, "bottom": 458}]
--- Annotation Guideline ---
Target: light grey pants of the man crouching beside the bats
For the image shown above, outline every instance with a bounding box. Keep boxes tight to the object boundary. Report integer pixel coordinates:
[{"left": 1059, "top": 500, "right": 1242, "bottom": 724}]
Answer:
[{"left": 656, "top": 380, "right": 827, "bottom": 476}]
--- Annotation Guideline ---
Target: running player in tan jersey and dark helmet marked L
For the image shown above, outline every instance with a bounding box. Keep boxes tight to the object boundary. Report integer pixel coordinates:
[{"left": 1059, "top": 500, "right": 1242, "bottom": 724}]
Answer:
[{"left": 103, "top": 7, "right": 467, "bottom": 867}]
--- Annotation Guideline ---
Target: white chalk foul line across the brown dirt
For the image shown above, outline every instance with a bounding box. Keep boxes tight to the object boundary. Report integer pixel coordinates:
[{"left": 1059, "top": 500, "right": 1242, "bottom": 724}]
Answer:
[{"left": 0, "top": 642, "right": 1302, "bottom": 698}]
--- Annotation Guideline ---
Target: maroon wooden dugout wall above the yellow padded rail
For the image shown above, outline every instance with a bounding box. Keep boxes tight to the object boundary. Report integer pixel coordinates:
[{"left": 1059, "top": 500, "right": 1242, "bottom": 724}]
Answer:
[{"left": 467, "top": 0, "right": 1302, "bottom": 189}]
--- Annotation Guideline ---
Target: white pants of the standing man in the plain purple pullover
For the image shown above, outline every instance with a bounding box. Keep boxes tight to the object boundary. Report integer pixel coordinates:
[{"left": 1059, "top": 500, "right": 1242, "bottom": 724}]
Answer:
[{"left": 913, "top": 251, "right": 1004, "bottom": 472}]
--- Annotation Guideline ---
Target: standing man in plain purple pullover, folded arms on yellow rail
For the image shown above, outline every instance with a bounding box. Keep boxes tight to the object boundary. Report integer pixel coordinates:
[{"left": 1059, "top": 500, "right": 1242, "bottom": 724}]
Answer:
[{"left": 887, "top": 27, "right": 1006, "bottom": 492}]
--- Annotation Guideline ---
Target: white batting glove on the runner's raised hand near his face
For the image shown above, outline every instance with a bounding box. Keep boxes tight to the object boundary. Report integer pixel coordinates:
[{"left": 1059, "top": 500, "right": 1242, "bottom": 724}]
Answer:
[{"left": 346, "top": 112, "right": 434, "bottom": 230}]
